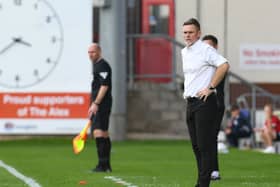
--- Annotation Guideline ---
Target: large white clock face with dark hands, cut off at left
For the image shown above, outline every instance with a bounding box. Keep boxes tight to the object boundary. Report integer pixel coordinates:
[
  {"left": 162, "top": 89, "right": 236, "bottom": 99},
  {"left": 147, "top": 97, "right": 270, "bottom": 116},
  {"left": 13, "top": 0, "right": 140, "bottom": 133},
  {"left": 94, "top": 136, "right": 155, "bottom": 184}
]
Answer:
[{"left": 0, "top": 0, "right": 63, "bottom": 88}]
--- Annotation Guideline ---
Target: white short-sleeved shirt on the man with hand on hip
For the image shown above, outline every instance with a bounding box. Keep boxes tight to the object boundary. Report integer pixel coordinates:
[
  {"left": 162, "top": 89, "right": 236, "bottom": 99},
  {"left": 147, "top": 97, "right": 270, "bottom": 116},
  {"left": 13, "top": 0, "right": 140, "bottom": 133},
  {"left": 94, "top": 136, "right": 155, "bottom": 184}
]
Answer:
[{"left": 181, "top": 40, "right": 227, "bottom": 98}]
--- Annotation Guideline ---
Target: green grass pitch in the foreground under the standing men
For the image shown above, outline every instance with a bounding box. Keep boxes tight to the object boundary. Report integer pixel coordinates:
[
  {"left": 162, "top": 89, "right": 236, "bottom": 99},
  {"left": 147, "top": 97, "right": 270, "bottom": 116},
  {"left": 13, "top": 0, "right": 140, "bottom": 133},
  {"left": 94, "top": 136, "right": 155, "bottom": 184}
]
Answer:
[{"left": 0, "top": 138, "right": 280, "bottom": 187}]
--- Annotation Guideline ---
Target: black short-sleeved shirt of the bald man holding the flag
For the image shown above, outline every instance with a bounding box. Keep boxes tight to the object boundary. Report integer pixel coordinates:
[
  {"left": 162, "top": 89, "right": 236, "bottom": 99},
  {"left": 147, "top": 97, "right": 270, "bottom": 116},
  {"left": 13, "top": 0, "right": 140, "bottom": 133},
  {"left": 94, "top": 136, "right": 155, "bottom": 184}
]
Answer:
[{"left": 91, "top": 59, "right": 112, "bottom": 110}]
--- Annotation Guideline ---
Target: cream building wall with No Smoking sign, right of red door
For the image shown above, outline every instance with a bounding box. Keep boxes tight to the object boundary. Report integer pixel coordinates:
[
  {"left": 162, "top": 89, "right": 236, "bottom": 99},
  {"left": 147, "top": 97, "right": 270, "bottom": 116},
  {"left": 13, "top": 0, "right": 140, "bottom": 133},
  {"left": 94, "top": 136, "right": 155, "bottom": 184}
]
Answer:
[{"left": 175, "top": 0, "right": 280, "bottom": 85}]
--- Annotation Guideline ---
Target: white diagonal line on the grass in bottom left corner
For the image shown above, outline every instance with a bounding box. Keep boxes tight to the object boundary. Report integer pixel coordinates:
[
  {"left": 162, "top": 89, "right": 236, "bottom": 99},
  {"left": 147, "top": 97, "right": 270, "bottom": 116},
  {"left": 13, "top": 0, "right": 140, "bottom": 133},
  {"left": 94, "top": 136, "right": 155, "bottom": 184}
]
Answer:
[{"left": 0, "top": 160, "right": 41, "bottom": 187}]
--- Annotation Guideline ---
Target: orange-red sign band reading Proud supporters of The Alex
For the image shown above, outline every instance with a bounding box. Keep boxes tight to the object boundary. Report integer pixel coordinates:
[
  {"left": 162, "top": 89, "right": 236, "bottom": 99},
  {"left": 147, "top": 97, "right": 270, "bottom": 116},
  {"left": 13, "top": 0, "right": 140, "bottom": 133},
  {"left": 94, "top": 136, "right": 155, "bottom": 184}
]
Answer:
[{"left": 0, "top": 93, "right": 90, "bottom": 119}]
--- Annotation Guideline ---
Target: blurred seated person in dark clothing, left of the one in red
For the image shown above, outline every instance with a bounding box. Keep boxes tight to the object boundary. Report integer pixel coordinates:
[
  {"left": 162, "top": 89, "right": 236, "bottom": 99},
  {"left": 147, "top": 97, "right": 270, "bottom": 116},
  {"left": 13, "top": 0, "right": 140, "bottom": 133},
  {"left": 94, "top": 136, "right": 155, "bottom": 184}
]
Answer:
[{"left": 225, "top": 105, "right": 252, "bottom": 147}]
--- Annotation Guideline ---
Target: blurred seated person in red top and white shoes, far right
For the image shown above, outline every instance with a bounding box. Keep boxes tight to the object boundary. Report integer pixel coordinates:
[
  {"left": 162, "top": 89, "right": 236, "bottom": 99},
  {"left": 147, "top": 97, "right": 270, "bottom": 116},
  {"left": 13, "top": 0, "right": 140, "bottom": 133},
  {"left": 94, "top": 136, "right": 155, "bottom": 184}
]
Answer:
[{"left": 255, "top": 104, "right": 280, "bottom": 153}]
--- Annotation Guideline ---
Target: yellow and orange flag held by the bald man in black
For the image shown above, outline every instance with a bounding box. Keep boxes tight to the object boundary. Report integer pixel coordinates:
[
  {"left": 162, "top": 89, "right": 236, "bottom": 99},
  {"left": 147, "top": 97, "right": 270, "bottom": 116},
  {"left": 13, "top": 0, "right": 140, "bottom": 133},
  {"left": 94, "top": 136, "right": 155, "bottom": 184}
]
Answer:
[{"left": 72, "top": 120, "right": 91, "bottom": 154}]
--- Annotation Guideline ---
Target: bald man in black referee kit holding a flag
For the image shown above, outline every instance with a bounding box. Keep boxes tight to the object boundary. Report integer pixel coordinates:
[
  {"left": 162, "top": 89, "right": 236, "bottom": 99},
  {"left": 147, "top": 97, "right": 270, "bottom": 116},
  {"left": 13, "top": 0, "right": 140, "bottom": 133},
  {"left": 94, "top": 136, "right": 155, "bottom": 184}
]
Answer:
[{"left": 88, "top": 43, "right": 112, "bottom": 172}]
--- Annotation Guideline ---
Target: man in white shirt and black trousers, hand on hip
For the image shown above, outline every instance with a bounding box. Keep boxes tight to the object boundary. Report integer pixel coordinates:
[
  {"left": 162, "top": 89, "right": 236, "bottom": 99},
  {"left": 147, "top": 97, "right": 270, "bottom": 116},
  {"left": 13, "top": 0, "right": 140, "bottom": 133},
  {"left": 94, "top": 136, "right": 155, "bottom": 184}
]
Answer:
[{"left": 181, "top": 18, "right": 229, "bottom": 187}]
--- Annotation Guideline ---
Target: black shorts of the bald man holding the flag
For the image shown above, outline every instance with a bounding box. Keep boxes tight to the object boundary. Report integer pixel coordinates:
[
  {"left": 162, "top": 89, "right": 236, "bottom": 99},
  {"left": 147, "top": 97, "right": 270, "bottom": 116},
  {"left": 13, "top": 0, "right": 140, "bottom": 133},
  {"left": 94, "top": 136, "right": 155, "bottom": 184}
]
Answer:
[{"left": 91, "top": 110, "right": 111, "bottom": 131}]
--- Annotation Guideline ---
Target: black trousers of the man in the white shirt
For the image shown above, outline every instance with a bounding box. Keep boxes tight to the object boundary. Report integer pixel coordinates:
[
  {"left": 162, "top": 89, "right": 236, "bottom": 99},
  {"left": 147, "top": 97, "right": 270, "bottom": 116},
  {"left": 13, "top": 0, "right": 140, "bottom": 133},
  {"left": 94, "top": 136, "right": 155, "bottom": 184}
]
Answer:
[{"left": 187, "top": 94, "right": 218, "bottom": 187}]
